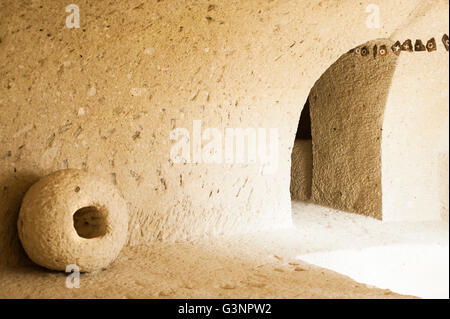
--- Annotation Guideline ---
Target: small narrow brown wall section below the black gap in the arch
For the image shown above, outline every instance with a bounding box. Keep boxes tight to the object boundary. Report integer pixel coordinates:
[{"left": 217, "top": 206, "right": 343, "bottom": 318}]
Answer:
[{"left": 291, "top": 140, "right": 313, "bottom": 201}]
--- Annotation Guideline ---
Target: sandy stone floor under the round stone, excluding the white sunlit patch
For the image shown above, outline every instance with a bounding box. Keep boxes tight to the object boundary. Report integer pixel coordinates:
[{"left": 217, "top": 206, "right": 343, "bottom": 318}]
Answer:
[{"left": 0, "top": 202, "right": 448, "bottom": 298}]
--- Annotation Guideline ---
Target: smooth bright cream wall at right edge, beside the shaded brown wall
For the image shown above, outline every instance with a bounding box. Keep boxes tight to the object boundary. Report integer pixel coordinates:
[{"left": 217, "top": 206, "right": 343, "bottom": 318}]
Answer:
[{"left": 382, "top": 2, "right": 449, "bottom": 221}]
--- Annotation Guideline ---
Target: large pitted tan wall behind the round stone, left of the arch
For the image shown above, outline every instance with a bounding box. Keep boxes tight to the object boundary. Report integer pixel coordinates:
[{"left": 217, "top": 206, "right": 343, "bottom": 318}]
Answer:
[{"left": 0, "top": 0, "right": 434, "bottom": 264}]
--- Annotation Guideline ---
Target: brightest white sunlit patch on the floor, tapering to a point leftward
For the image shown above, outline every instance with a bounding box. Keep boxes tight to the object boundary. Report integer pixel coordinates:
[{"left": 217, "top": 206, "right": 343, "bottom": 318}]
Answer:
[{"left": 298, "top": 241, "right": 449, "bottom": 298}]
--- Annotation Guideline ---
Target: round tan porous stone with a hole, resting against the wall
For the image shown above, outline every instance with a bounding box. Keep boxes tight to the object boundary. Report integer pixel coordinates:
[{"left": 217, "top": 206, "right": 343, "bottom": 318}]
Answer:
[{"left": 17, "top": 169, "right": 128, "bottom": 272}]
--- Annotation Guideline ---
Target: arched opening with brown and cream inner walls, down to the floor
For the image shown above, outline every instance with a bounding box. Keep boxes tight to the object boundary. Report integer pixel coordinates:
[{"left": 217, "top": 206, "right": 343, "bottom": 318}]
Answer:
[{"left": 290, "top": 39, "right": 448, "bottom": 221}]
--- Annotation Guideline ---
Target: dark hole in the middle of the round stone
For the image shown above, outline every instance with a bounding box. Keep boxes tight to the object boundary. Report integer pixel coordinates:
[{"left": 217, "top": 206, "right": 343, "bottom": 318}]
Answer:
[{"left": 73, "top": 206, "right": 107, "bottom": 239}]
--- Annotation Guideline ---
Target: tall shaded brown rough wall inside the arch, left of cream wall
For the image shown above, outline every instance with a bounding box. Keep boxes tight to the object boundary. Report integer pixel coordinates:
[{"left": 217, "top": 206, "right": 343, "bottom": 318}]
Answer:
[{"left": 310, "top": 39, "right": 397, "bottom": 219}]
